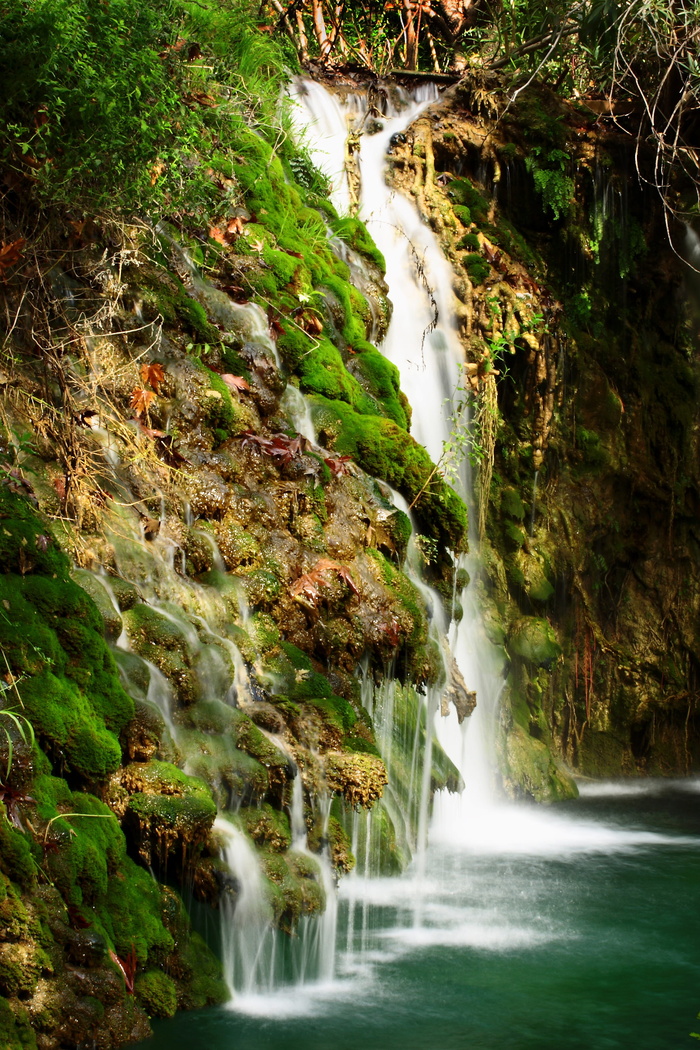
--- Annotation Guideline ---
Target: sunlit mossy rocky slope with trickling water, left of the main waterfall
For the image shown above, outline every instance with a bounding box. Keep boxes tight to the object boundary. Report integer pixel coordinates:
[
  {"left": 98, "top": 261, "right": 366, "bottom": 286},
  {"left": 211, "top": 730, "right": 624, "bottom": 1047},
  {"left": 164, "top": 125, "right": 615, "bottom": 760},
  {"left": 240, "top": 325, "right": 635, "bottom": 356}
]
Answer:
[{"left": 0, "top": 79, "right": 466, "bottom": 1050}]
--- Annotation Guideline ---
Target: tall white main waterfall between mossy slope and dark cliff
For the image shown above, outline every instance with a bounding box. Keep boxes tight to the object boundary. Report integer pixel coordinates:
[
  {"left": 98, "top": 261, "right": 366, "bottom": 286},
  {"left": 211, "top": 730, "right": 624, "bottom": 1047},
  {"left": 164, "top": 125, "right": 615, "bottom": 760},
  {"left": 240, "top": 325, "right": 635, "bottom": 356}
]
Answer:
[{"left": 294, "top": 81, "right": 503, "bottom": 834}]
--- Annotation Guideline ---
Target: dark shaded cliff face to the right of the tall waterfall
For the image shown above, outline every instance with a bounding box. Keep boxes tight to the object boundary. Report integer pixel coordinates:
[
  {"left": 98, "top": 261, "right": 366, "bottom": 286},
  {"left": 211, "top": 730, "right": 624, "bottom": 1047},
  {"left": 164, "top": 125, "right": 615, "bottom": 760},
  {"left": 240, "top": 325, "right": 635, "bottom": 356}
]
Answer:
[{"left": 393, "top": 74, "right": 700, "bottom": 798}]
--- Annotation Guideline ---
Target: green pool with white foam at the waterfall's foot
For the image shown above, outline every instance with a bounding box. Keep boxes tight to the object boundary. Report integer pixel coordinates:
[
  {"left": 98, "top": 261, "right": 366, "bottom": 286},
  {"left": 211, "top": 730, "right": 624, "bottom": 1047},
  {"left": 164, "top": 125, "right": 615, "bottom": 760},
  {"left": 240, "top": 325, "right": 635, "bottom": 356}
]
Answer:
[{"left": 134, "top": 781, "right": 700, "bottom": 1050}]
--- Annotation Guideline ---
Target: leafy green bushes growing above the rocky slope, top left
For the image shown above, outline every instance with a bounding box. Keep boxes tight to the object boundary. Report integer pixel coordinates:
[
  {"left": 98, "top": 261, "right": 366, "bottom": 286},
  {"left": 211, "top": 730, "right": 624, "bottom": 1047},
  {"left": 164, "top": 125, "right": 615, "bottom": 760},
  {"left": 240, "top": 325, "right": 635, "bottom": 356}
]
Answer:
[{"left": 0, "top": 0, "right": 293, "bottom": 215}]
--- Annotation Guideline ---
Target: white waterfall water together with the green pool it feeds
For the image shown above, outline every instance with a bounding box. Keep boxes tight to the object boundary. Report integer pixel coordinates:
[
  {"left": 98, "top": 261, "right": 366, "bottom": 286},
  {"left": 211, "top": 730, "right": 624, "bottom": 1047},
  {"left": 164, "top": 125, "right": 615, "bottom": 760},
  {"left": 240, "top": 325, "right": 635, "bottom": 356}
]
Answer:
[{"left": 132, "top": 84, "right": 700, "bottom": 1050}]
